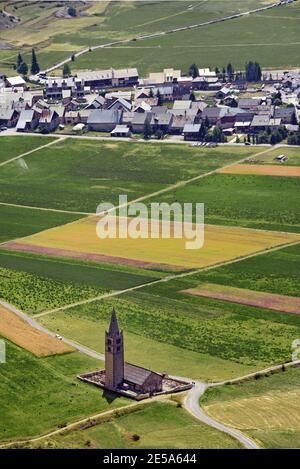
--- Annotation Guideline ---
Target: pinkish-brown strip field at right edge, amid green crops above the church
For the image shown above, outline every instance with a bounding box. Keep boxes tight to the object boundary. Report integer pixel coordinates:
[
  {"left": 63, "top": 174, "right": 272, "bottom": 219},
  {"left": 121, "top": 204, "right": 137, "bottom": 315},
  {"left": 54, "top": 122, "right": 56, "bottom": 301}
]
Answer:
[{"left": 182, "top": 283, "right": 300, "bottom": 314}]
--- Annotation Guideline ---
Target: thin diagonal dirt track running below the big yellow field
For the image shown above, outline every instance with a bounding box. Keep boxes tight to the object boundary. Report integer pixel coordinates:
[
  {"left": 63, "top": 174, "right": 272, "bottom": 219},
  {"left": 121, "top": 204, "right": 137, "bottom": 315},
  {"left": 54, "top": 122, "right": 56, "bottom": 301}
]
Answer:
[{"left": 34, "top": 239, "right": 300, "bottom": 318}]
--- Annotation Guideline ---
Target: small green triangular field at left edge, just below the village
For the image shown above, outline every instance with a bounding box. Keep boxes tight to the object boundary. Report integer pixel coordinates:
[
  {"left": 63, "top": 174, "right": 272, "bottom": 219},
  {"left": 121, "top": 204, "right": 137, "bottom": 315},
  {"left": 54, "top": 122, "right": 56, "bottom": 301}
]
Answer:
[{"left": 0, "top": 135, "right": 53, "bottom": 166}]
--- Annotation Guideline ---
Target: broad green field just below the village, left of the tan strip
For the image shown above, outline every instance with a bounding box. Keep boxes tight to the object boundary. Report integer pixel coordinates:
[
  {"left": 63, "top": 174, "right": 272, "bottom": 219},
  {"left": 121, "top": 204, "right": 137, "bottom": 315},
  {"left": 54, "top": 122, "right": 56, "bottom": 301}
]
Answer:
[{"left": 0, "top": 137, "right": 254, "bottom": 212}]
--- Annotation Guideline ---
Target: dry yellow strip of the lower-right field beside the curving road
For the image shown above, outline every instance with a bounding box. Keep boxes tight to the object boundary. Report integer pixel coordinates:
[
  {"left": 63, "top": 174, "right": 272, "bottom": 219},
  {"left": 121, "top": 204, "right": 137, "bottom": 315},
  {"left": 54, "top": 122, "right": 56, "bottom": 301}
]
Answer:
[{"left": 204, "top": 388, "right": 300, "bottom": 431}]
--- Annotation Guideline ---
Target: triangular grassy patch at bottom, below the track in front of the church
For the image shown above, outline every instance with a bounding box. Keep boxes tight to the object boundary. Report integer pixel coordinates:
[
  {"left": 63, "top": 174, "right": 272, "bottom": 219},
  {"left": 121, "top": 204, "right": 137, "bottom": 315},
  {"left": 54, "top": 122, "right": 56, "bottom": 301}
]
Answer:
[{"left": 21, "top": 401, "right": 240, "bottom": 449}]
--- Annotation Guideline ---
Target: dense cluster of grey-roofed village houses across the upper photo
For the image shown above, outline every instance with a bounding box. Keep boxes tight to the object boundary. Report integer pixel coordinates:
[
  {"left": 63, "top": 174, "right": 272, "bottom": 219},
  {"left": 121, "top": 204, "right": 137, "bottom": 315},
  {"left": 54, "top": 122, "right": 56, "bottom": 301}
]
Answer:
[{"left": 0, "top": 68, "right": 300, "bottom": 143}]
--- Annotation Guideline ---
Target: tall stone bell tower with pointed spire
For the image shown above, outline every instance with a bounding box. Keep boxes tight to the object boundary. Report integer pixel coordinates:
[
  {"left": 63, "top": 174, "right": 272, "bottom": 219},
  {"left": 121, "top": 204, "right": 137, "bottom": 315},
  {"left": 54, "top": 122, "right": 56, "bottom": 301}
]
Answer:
[{"left": 105, "top": 308, "right": 124, "bottom": 390}]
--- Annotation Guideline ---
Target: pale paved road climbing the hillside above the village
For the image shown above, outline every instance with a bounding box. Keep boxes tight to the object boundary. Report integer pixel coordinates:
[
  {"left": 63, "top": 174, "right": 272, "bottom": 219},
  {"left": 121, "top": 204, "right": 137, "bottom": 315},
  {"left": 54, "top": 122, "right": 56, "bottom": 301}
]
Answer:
[{"left": 39, "top": 2, "right": 280, "bottom": 78}]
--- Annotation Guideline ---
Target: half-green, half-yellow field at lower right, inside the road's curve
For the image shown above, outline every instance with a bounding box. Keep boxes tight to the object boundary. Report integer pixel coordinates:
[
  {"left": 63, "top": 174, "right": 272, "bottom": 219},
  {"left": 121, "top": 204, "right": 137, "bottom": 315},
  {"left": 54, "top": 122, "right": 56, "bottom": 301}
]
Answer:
[{"left": 201, "top": 368, "right": 300, "bottom": 448}]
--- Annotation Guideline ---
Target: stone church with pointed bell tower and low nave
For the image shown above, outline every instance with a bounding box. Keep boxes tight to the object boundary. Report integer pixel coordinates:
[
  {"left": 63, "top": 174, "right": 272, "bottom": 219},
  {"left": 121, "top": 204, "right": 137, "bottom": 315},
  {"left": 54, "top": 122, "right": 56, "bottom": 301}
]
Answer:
[{"left": 105, "top": 309, "right": 163, "bottom": 394}]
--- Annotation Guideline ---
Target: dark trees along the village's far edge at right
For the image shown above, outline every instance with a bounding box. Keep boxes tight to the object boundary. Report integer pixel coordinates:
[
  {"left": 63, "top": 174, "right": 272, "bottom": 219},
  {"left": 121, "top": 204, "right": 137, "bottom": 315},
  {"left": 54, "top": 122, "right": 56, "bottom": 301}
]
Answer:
[{"left": 189, "top": 61, "right": 262, "bottom": 82}]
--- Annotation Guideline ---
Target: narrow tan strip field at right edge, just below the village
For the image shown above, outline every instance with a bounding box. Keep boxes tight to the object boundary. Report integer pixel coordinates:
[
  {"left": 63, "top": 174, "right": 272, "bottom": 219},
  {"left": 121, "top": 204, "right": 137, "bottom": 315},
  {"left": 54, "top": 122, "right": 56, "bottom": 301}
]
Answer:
[{"left": 217, "top": 164, "right": 300, "bottom": 177}]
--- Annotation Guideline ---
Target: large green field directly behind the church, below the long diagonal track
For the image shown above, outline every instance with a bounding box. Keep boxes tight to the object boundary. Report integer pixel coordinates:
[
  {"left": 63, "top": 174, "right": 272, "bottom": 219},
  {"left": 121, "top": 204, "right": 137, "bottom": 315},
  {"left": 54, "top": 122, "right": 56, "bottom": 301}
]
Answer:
[{"left": 37, "top": 248, "right": 300, "bottom": 380}]
